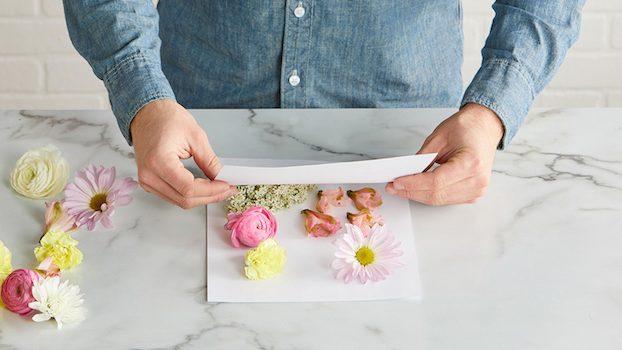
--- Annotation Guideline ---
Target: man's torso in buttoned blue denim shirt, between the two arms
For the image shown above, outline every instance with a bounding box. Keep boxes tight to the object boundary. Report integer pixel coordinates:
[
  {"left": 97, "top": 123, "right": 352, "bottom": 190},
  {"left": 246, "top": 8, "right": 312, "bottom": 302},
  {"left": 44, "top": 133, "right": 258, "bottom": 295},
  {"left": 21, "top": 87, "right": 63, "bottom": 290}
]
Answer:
[{"left": 158, "top": 0, "right": 462, "bottom": 108}]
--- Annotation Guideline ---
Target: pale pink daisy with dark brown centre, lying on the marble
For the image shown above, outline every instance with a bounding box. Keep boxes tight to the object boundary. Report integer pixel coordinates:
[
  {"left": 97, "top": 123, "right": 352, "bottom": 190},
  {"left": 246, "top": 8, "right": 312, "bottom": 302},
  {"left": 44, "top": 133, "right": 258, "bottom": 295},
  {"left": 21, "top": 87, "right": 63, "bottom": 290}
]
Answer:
[{"left": 63, "top": 165, "right": 137, "bottom": 231}]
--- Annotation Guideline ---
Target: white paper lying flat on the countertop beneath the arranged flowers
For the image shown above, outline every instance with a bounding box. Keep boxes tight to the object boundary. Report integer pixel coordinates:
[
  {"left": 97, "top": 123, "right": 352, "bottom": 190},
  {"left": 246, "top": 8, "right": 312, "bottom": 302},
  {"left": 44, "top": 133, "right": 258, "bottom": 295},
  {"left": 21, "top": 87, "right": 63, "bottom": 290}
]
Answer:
[{"left": 207, "top": 160, "right": 422, "bottom": 302}]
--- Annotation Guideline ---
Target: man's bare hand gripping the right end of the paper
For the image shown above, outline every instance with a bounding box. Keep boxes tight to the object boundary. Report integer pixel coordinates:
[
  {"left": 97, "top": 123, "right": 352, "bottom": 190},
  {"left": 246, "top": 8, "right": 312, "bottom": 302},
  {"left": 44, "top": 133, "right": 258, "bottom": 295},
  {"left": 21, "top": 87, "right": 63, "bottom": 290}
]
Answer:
[{"left": 386, "top": 103, "right": 503, "bottom": 205}]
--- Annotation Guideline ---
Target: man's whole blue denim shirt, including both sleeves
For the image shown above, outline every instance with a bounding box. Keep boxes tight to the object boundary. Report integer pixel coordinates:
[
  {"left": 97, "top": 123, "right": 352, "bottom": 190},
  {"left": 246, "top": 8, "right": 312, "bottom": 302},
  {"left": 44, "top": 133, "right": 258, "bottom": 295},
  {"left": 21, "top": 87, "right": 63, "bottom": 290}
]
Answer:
[{"left": 64, "top": 0, "right": 584, "bottom": 147}]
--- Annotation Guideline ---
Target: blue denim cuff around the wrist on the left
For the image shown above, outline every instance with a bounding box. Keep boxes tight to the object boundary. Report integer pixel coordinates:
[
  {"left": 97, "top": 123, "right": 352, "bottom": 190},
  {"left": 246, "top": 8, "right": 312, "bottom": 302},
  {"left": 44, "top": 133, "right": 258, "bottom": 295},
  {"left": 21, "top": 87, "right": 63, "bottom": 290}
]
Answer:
[{"left": 103, "top": 53, "right": 175, "bottom": 145}]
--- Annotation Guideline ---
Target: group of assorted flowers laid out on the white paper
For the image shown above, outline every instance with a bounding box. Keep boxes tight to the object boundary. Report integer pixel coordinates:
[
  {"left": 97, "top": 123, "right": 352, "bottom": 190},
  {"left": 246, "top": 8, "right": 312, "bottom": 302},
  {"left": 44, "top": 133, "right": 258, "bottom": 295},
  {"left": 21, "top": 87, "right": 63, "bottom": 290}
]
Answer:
[{"left": 225, "top": 185, "right": 403, "bottom": 284}]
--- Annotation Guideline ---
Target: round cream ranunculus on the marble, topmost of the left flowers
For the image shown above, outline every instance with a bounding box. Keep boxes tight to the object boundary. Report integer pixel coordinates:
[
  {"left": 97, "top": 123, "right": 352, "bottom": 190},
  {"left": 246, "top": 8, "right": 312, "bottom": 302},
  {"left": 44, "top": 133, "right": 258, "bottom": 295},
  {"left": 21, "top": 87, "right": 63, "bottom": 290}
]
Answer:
[{"left": 10, "top": 145, "right": 69, "bottom": 198}]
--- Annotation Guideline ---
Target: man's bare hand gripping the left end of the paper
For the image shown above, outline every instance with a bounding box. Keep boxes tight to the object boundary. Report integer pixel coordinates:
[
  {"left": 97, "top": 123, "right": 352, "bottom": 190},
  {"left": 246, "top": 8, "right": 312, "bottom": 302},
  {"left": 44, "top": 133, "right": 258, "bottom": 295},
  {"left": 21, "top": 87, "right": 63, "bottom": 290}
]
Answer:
[{"left": 130, "top": 100, "right": 236, "bottom": 209}]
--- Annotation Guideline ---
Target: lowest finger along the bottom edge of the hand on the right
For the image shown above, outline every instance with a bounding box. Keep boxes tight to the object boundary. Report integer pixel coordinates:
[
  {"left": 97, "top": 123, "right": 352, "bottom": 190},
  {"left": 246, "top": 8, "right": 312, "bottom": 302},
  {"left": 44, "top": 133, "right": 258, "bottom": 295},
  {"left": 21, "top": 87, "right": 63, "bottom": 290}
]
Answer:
[{"left": 387, "top": 176, "right": 488, "bottom": 205}]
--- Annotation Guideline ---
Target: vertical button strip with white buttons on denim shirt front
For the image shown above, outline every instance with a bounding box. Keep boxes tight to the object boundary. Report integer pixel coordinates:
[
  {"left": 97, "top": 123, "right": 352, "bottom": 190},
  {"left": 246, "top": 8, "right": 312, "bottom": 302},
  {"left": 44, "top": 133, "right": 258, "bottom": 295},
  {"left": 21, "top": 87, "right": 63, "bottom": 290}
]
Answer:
[{"left": 281, "top": 0, "right": 313, "bottom": 108}]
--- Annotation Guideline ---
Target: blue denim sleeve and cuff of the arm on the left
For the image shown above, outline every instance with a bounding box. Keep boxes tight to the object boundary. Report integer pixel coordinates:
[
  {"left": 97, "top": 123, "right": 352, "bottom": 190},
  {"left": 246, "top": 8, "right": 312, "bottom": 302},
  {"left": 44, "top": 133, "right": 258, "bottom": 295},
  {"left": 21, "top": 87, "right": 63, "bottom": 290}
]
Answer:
[{"left": 63, "top": 0, "right": 175, "bottom": 143}]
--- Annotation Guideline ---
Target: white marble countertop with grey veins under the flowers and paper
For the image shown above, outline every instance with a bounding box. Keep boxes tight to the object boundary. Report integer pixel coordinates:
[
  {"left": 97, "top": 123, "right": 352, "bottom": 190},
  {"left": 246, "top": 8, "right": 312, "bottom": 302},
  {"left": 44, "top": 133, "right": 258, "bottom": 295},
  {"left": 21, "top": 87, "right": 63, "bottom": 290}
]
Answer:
[{"left": 0, "top": 109, "right": 622, "bottom": 350}]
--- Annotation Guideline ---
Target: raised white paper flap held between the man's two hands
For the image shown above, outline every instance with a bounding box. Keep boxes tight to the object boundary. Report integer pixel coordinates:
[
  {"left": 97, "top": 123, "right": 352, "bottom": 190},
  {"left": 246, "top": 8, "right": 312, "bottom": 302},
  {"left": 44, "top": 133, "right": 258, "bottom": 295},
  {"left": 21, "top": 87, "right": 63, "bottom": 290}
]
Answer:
[{"left": 217, "top": 153, "right": 436, "bottom": 185}]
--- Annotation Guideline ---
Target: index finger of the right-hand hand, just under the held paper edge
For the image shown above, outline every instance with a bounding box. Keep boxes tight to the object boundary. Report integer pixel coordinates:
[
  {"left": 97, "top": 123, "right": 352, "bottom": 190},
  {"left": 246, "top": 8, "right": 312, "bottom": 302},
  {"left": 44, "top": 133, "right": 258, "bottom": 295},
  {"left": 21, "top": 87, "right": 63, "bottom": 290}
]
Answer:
[{"left": 390, "top": 157, "right": 473, "bottom": 191}]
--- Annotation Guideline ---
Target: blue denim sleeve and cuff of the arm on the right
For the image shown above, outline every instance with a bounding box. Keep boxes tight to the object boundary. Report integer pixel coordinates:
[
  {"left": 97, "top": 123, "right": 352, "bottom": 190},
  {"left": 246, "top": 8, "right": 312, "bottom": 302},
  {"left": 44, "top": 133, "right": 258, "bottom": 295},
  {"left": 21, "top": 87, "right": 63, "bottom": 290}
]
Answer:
[{"left": 461, "top": 0, "right": 585, "bottom": 148}]
